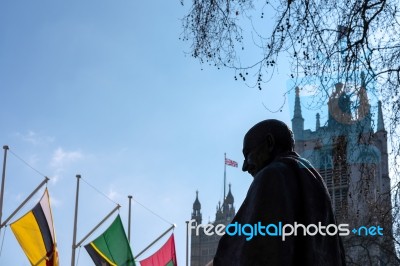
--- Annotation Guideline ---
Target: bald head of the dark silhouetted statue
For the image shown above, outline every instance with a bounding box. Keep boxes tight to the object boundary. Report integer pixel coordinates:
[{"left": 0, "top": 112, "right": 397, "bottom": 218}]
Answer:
[{"left": 242, "top": 119, "right": 294, "bottom": 177}]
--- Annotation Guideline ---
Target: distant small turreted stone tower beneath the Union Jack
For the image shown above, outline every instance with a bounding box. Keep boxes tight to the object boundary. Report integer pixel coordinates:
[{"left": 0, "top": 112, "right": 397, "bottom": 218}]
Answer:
[{"left": 190, "top": 184, "right": 235, "bottom": 266}]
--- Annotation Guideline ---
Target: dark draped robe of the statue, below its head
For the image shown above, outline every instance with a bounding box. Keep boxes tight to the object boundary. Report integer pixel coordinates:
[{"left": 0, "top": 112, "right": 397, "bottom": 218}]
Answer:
[{"left": 214, "top": 152, "right": 345, "bottom": 266}]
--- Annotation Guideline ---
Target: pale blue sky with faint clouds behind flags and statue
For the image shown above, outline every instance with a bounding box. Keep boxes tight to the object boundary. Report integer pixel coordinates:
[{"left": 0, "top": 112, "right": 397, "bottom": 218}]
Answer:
[{"left": 0, "top": 0, "right": 306, "bottom": 266}]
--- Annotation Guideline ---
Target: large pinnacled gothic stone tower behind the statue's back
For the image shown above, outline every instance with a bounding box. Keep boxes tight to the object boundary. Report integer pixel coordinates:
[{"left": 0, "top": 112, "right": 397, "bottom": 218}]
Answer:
[{"left": 292, "top": 82, "right": 394, "bottom": 265}]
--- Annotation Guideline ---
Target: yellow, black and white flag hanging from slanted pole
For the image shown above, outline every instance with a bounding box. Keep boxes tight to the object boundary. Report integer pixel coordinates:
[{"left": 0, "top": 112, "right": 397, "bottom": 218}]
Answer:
[{"left": 10, "top": 188, "right": 59, "bottom": 266}]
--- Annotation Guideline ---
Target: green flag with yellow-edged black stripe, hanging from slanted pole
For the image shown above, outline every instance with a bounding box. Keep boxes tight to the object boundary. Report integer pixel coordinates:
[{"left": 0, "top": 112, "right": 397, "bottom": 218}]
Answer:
[{"left": 85, "top": 214, "right": 135, "bottom": 266}]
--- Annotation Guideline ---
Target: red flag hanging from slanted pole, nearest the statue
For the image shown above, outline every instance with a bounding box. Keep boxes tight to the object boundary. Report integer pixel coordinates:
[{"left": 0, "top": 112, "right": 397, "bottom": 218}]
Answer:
[{"left": 140, "top": 234, "right": 177, "bottom": 266}]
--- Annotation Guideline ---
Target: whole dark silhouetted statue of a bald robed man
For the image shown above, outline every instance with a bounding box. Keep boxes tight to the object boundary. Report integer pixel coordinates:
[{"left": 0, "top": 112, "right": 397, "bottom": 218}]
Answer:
[{"left": 210, "top": 119, "right": 347, "bottom": 266}]
